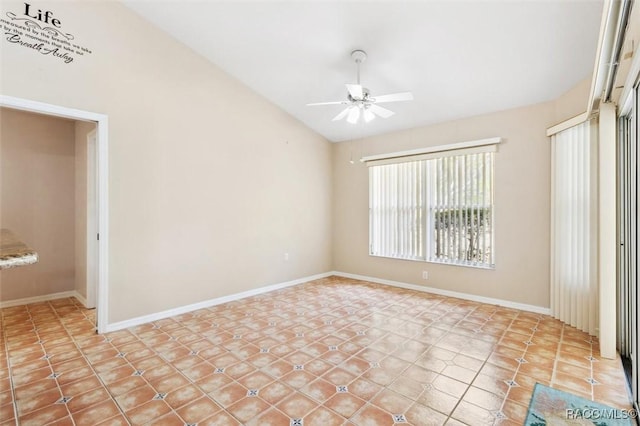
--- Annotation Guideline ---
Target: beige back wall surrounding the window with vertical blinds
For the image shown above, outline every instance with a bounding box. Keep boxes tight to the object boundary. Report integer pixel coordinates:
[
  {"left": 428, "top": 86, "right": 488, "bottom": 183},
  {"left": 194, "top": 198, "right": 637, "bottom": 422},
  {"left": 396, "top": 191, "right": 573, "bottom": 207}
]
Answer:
[{"left": 333, "top": 103, "right": 555, "bottom": 307}]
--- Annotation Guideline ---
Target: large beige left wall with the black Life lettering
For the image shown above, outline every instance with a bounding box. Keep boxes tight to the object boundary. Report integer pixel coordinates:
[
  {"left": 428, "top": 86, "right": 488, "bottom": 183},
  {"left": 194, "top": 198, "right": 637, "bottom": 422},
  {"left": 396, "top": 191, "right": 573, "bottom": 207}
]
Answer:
[{"left": 0, "top": 1, "right": 331, "bottom": 322}]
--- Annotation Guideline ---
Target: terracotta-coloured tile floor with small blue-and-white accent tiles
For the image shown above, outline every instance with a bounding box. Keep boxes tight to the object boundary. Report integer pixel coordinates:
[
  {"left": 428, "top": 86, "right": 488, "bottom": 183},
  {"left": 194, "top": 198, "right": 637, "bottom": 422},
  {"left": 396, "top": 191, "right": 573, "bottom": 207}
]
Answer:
[{"left": 0, "top": 277, "right": 630, "bottom": 426}]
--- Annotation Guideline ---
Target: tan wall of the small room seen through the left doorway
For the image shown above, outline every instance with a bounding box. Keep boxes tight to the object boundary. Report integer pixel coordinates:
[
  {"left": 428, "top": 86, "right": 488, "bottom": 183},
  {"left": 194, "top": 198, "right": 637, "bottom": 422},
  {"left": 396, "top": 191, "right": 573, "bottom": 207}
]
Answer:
[{"left": 0, "top": 108, "right": 75, "bottom": 301}]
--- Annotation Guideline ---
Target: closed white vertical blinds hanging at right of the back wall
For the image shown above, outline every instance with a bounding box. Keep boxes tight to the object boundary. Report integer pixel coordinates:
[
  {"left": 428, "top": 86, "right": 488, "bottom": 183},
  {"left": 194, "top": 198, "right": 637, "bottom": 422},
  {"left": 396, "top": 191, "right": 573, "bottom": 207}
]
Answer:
[{"left": 551, "top": 122, "right": 598, "bottom": 334}]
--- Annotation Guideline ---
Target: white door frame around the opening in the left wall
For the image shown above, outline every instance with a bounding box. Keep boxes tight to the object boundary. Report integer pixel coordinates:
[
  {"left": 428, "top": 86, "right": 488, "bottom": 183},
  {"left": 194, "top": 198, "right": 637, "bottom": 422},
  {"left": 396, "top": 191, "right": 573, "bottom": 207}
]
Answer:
[{"left": 0, "top": 95, "right": 109, "bottom": 333}]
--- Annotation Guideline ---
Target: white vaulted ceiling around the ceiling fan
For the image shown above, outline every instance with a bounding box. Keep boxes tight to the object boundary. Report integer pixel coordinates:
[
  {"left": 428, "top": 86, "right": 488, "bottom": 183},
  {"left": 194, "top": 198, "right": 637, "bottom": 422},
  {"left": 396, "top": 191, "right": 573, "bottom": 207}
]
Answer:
[{"left": 124, "top": 0, "right": 602, "bottom": 141}]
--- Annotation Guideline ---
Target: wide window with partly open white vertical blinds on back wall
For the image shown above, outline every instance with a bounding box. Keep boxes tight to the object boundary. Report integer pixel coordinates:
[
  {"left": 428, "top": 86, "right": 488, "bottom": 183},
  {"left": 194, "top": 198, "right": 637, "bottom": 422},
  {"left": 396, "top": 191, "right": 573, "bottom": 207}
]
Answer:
[{"left": 369, "top": 145, "right": 495, "bottom": 268}]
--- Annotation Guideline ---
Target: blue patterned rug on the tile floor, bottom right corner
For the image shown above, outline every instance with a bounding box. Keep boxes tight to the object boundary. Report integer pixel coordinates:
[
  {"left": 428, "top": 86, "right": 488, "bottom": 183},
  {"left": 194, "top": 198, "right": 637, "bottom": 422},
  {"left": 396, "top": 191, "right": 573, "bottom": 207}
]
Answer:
[{"left": 524, "top": 383, "right": 636, "bottom": 426}]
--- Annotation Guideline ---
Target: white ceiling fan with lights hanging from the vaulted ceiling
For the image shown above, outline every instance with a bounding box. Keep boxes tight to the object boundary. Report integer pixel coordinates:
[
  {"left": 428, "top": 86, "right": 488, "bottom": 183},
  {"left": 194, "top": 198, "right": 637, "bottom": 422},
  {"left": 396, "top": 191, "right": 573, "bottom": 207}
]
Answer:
[{"left": 307, "top": 50, "right": 413, "bottom": 124}]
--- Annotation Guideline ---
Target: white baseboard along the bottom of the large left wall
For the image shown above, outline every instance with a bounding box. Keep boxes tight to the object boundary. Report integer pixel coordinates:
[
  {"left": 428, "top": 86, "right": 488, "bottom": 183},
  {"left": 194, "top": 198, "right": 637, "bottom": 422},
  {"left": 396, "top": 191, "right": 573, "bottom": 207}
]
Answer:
[{"left": 106, "top": 272, "right": 333, "bottom": 332}]
